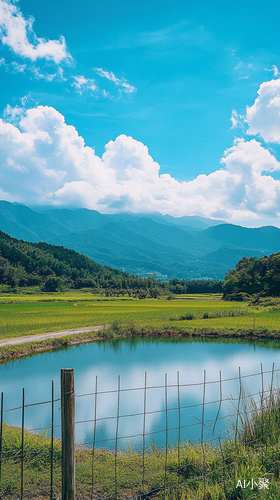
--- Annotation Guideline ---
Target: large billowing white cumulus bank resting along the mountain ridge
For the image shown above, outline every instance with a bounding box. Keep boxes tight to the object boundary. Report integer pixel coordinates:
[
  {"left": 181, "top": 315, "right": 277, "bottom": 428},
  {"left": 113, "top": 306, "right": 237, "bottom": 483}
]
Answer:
[{"left": 0, "top": 106, "right": 280, "bottom": 221}]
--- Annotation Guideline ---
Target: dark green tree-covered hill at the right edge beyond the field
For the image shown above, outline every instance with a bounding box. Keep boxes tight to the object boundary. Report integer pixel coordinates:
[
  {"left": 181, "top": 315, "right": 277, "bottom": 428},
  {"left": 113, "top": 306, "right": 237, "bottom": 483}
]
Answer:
[{"left": 223, "top": 252, "right": 280, "bottom": 300}]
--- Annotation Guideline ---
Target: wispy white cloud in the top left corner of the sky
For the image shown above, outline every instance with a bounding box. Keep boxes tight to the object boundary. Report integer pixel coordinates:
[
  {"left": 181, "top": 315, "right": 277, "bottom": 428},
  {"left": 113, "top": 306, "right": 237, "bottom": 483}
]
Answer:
[{"left": 0, "top": 0, "right": 71, "bottom": 64}]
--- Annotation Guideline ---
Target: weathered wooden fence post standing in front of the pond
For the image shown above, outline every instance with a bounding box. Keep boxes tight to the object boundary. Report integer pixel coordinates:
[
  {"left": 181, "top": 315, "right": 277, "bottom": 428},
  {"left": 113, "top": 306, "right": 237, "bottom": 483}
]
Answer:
[{"left": 61, "top": 368, "right": 76, "bottom": 500}]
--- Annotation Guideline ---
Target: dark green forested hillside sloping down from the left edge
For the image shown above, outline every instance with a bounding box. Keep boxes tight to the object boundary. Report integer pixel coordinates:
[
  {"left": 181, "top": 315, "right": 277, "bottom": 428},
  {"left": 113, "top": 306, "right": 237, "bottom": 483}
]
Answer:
[{"left": 0, "top": 231, "right": 160, "bottom": 294}]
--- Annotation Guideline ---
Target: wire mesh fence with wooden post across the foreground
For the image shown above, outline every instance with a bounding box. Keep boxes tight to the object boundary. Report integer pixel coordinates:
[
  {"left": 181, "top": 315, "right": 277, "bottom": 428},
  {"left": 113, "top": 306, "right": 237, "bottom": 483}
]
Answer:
[{"left": 0, "top": 363, "right": 280, "bottom": 500}]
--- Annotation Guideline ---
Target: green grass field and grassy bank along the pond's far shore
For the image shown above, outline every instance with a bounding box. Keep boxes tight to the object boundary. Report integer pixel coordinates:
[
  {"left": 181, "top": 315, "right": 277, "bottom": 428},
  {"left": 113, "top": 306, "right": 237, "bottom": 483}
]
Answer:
[{"left": 0, "top": 292, "right": 280, "bottom": 362}]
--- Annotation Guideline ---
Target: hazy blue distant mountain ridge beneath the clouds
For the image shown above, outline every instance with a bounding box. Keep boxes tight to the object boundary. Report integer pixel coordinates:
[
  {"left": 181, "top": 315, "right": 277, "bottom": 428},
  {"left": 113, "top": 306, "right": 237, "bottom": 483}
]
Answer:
[{"left": 0, "top": 201, "right": 280, "bottom": 279}]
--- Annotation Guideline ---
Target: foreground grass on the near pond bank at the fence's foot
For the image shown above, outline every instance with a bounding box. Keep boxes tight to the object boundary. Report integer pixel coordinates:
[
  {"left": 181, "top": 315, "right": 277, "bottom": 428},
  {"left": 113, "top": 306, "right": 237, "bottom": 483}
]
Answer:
[{"left": 2, "top": 392, "right": 280, "bottom": 500}]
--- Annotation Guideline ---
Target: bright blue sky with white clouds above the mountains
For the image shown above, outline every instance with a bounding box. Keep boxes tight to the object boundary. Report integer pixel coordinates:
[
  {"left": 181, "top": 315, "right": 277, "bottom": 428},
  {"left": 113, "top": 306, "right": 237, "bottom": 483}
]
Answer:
[{"left": 0, "top": 0, "right": 280, "bottom": 225}]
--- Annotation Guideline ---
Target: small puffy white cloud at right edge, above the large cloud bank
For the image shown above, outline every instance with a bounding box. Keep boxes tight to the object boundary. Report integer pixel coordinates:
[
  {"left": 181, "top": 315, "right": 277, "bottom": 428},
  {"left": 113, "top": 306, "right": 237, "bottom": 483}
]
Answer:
[{"left": 246, "top": 79, "right": 280, "bottom": 143}]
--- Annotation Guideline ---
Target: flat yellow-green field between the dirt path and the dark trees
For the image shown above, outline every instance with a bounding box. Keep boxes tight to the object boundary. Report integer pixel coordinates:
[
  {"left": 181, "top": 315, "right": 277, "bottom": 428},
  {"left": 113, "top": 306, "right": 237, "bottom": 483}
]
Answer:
[{"left": 0, "top": 293, "right": 280, "bottom": 339}]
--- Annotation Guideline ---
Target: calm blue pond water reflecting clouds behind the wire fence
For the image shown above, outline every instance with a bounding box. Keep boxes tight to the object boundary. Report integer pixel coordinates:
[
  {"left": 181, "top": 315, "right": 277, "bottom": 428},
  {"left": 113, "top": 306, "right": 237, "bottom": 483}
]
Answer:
[{"left": 0, "top": 338, "right": 280, "bottom": 449}]
